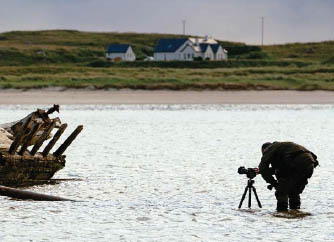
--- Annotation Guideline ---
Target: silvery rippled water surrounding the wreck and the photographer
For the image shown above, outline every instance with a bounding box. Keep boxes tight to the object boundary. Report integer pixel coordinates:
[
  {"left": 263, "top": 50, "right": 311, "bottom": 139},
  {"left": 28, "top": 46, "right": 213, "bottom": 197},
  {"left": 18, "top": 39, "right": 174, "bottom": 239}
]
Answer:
[{"left": 0, "top": 105, "right": 334, "bottom": 241}]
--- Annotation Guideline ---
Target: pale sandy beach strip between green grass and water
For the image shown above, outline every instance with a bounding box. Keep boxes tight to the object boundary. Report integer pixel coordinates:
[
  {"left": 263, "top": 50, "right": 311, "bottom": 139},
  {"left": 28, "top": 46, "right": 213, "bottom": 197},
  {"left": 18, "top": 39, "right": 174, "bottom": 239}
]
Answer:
[{"left": 0, "top": 89, "right": 334, "bottom": 105}]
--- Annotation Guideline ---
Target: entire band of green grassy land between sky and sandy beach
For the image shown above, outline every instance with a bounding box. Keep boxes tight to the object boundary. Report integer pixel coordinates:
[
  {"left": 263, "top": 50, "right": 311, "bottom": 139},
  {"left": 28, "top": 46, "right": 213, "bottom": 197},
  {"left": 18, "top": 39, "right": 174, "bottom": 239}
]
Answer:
[{"left": 0, "top": 30, "right": 334, "bottom": 90}]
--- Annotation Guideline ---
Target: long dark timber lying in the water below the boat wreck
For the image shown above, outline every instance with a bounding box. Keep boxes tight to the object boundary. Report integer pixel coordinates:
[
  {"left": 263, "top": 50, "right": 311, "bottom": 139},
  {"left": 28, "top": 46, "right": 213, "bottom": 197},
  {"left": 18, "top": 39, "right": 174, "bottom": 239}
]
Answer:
[{"left": 0, "top": 186, "right": 74, "bottom": 201}]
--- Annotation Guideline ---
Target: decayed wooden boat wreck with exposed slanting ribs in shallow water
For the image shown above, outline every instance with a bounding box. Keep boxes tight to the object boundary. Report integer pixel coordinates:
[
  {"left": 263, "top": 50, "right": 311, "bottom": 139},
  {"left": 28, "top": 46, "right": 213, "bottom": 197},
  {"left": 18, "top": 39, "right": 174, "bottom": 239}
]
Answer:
[{"left": 0, "top": 105, "right": 83, "bottom": 186}]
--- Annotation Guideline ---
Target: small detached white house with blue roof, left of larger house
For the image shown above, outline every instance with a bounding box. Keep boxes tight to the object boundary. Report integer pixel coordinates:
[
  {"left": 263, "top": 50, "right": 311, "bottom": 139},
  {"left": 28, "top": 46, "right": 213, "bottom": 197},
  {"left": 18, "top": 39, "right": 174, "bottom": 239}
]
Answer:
[{"left": 106, "top": 44, "right": 136, "bottom": 61}]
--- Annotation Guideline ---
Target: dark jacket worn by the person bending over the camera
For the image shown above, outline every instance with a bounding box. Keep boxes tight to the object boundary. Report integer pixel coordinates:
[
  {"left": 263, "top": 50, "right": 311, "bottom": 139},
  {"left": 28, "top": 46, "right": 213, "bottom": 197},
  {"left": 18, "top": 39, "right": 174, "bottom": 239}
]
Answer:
[{"left": 259, "top": 142, "right": 318, "bottom": 185}]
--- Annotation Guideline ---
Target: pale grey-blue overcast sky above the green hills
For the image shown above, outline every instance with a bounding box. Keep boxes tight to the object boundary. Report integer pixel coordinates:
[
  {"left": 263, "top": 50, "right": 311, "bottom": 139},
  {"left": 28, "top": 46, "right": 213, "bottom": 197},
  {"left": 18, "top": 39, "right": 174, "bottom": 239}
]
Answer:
[{"left": 0, "top": 0, "right": 334, "bottom": 44}]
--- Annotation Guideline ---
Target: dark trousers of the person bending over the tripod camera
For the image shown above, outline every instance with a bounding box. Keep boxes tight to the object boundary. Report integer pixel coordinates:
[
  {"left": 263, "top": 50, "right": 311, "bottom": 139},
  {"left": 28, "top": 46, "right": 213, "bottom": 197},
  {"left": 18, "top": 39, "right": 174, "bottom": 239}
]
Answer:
[{"left": 275, "top": 164, "right": 314, "bottom": 211}]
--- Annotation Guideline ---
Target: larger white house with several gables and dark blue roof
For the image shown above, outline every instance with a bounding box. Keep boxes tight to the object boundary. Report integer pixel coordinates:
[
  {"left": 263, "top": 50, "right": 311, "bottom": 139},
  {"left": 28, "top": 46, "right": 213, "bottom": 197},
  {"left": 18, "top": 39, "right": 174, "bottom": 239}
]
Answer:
[{"left": 154, "top": 38, "right": 227, "bottom": 61}]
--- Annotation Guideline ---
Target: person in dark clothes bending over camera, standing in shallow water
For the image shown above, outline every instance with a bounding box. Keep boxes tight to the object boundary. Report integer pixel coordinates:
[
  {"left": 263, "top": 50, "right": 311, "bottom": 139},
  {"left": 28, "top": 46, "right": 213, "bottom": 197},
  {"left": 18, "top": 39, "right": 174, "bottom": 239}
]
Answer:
[{"left": 259, "top": 142, "right": 319, "bottom": 211}]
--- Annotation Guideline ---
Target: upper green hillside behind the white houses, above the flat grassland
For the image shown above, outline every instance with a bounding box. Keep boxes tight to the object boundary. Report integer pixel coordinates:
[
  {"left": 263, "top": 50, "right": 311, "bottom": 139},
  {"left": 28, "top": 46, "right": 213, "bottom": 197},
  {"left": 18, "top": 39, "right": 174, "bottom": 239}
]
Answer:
[{"left": 0, "top": 30, "right": 334, "bottom": 65}]
